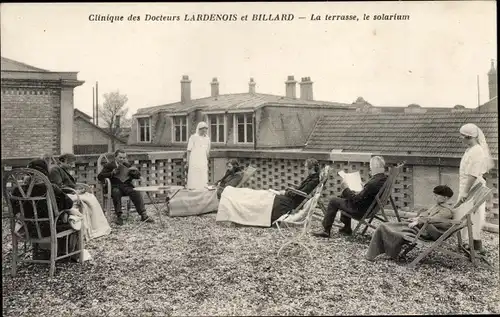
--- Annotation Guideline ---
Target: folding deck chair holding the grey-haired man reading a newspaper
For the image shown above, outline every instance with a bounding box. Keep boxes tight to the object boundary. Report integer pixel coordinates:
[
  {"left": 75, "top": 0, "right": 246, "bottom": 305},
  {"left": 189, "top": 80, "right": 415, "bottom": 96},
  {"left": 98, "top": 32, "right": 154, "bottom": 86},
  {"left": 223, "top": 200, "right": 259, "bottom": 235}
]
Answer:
[{"left": 341, "top": 162, "right": 405, "bottom": 236}]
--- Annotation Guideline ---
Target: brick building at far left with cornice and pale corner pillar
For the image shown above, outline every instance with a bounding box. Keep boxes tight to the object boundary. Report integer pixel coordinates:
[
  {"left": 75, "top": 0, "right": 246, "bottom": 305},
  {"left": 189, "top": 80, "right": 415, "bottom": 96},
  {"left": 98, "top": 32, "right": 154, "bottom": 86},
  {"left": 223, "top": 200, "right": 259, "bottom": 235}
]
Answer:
[{"left": 1, "top": 57, "right": 84, "bottom": 158}]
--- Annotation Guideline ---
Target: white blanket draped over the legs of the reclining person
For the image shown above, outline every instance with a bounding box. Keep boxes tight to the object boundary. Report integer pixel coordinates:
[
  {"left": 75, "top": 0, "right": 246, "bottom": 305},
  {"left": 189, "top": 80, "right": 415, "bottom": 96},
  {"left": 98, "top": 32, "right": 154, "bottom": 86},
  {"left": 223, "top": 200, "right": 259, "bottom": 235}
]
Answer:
[{"left": 216, "top": 186, "right": 275, "bottom": 227}]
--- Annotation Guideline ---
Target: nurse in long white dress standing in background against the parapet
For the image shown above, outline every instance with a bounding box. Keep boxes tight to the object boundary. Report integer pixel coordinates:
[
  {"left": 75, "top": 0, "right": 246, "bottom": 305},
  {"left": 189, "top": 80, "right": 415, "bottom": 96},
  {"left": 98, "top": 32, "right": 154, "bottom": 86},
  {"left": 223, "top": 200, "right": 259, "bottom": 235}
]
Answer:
[{"left": 187, "top": 121, "right": 210, "bottom": 189}]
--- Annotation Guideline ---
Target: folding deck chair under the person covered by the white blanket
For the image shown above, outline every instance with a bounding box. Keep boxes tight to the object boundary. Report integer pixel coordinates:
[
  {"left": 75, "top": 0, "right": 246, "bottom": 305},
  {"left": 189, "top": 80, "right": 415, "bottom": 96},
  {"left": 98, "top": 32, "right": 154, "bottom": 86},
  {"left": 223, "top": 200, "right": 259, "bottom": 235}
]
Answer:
[{"left": 271, "top": 165, "right": 331, "bottom": 259}]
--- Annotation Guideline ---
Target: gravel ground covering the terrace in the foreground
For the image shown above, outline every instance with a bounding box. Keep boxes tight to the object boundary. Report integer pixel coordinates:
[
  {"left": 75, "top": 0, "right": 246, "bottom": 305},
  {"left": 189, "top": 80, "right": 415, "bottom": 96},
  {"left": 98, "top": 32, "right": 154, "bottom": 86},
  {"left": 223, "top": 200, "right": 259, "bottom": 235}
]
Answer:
[{"left": 2, "top": 207, "right": 500, "bottom": 317}]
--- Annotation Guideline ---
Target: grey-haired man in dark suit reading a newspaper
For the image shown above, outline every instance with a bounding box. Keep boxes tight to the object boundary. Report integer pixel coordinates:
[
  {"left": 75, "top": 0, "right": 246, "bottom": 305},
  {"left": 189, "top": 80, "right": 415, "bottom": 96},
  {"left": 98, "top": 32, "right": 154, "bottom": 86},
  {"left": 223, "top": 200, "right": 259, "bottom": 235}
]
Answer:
[{"left": 313, "top": 156, "right": 387, "bottom": 238}]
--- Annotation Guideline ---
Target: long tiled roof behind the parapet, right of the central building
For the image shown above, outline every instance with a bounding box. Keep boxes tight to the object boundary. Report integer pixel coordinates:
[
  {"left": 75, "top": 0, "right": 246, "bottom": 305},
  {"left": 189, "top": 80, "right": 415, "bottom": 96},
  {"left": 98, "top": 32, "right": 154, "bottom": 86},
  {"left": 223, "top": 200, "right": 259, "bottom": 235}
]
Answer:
[{"left": 305, "top": 112, "right": 498, "bottom": 158}]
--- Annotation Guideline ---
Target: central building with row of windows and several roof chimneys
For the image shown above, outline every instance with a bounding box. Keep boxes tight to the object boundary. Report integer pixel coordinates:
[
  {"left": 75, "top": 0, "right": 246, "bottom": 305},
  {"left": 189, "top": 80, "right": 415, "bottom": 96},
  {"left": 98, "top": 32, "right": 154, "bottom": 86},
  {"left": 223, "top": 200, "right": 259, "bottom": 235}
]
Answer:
[{"left": 128, "top": 76, "right": 354, "bottom": 150}]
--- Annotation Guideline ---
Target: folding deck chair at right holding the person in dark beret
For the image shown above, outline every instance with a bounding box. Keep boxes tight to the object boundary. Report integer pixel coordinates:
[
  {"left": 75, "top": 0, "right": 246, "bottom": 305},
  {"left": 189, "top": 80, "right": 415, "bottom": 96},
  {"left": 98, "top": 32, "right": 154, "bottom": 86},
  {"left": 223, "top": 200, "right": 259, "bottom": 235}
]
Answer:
[{"left": 399, "top": 184, "right": 493, "bottom": 269}]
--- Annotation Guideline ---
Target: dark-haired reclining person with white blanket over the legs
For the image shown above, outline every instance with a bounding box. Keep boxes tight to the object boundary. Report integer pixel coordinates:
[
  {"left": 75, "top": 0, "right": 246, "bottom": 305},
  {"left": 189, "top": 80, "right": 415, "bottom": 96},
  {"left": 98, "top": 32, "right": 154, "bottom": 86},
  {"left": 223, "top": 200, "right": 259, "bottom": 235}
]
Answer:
[{"left": 216, "top": 158, "right": 320, "bottom": 227}]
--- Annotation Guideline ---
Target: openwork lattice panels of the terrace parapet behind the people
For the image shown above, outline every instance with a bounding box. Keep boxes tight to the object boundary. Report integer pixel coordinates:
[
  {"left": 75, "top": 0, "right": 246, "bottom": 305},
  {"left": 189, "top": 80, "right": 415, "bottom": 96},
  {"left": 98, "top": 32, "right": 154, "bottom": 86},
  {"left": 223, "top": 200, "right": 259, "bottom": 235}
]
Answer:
[{"left": 2, "top": 152, "right": 498, "bottom": 225}]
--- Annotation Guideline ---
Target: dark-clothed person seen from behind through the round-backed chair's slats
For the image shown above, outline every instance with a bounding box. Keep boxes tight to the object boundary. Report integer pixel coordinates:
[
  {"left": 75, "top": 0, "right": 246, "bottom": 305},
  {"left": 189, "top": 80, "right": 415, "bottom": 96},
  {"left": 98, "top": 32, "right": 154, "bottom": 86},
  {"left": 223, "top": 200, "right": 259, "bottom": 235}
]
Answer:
[{"left": 12, "top": 159, "right": 81, "bottom": 260}]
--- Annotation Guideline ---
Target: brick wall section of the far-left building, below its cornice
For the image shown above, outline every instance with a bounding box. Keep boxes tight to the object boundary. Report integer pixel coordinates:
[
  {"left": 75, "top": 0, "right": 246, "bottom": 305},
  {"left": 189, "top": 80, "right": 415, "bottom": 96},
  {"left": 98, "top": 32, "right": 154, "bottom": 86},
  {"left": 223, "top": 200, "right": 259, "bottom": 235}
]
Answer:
[{"left": 1, "top": 84, "right": 61, "bottom": 158}]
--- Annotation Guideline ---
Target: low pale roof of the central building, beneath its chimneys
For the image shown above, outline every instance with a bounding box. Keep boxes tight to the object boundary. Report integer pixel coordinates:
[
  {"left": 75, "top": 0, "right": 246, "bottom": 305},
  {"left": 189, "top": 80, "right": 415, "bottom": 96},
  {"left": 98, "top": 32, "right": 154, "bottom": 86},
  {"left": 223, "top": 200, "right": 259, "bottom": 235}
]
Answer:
[{"left": 136, "top": 93, "right": 348, "bottom": 115}]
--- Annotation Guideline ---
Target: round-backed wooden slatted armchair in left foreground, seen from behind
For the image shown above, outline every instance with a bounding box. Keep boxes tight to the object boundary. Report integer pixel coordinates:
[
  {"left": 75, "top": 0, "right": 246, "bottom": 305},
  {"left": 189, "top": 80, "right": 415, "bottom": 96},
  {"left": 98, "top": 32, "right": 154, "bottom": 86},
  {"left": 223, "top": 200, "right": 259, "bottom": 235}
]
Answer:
[{"left": 3, "top": 168, "right": 84, "bottom": 277}]
